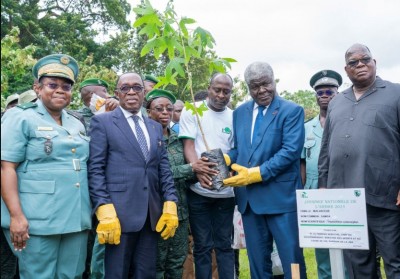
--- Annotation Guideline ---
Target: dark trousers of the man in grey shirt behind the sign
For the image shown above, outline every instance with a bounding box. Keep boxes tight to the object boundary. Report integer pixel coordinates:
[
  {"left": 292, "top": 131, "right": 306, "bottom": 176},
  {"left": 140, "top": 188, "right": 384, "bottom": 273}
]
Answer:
[{"left": 344, "top": 204, "right": 400, "bottom": 279}]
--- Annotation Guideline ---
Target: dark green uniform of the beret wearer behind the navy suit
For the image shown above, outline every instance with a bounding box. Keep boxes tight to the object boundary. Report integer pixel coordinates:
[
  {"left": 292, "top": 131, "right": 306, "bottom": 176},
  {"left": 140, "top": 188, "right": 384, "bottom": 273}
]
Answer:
[{"left": 156, "top": 129, "right": 194, "bottom": 279}]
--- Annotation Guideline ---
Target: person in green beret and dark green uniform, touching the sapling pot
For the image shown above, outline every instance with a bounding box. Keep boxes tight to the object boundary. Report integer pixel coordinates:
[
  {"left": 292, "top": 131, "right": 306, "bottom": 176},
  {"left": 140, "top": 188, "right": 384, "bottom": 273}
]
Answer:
[{"left": 146, "top": 89, "right": 212, "bottom": 279}]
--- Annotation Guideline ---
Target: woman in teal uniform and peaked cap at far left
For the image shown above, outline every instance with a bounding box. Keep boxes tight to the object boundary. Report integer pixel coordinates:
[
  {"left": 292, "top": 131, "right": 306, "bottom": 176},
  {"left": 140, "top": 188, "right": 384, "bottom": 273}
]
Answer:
[{"left": 1, "top": 54, "right": 91, "bottom": 279}]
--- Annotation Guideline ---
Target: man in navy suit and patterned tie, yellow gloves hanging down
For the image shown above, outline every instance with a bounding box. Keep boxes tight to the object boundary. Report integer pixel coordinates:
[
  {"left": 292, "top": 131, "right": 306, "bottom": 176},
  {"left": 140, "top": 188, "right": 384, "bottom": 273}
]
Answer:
[{"left": 88, "top": 73, "right": 178, "bottom": 278}]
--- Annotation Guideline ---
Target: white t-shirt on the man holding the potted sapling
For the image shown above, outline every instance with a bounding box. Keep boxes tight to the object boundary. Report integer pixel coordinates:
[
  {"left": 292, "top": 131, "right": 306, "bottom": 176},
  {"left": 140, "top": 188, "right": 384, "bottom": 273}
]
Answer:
[{"left": 179, "top": 101, "right": 234, "bottom": 198}]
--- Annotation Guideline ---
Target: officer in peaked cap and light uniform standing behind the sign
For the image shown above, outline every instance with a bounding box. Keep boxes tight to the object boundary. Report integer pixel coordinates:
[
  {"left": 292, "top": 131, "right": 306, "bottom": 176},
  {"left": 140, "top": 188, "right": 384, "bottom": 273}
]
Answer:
[{"left": 300, "top": 70, "right": 342, "bottom": 279}]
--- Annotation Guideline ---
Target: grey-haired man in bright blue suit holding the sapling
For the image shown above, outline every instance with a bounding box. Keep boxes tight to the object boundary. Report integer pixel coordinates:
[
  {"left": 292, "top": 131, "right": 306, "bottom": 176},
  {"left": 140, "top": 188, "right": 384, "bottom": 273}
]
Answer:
[{"left": 224, "top": 62, "right": 306, "bottom": 279}]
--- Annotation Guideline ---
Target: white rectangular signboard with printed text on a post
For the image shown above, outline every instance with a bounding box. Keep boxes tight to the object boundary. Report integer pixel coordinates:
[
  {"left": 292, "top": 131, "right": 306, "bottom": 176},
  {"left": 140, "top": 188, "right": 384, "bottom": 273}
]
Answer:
[{"left": 296, "top": 188, "right": 369, "bottom": 250}]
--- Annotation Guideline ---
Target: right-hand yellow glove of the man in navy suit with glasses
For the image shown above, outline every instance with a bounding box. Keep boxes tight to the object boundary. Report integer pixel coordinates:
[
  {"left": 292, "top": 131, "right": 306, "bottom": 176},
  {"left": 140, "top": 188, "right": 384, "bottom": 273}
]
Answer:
[{"left": 156, "top": 201, "right": 179, "bottom": 239}]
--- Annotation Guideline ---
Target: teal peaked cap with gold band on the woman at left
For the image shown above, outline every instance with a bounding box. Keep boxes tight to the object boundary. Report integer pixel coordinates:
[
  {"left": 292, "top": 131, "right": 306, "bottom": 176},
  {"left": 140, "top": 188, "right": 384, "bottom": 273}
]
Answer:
[{"left": 32, "top": 54, "right": 79, "bottom": 83}]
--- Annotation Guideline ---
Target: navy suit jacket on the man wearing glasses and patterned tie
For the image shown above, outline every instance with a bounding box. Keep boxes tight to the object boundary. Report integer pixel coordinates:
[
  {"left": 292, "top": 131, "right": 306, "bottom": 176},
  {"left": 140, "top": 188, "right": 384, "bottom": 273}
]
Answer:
[{"left": 88, "top": 108, "right": 178, "bottom": 232}]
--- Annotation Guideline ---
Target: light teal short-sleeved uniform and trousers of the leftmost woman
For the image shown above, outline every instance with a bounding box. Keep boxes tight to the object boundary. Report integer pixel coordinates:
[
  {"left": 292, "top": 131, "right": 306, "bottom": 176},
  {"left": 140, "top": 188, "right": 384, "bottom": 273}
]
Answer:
[{"left": 1, "top": 101, "right": 91, "bottom": 278}]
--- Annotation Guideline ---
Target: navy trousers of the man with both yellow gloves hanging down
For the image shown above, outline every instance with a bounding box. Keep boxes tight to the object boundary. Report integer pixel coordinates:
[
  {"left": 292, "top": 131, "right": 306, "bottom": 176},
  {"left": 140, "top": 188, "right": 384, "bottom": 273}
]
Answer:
[{"left": 104, "top": 218, "right": 159, "bottom": 279}]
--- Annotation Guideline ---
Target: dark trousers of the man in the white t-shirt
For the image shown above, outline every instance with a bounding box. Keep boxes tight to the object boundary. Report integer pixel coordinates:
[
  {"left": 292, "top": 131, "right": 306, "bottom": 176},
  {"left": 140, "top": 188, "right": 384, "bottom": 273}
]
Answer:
[{"left": 187, "top": 190, "right": 235, "bottom": 279}]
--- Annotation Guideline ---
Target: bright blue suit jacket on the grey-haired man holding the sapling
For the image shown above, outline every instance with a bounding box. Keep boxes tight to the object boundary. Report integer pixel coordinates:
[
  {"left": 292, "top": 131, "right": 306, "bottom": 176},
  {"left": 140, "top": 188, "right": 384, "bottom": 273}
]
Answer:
[{"left": 229, "top": 96, "right": 304, "bottom": 214}]
